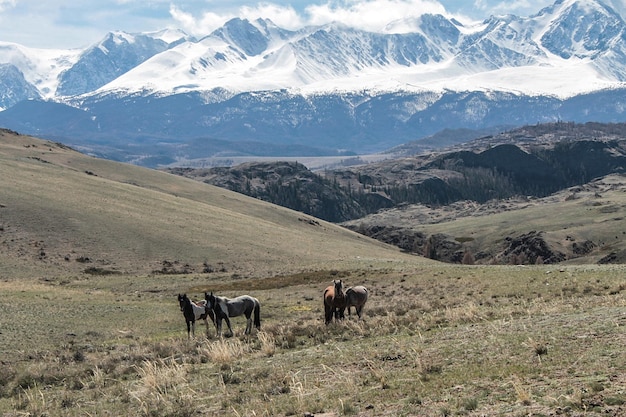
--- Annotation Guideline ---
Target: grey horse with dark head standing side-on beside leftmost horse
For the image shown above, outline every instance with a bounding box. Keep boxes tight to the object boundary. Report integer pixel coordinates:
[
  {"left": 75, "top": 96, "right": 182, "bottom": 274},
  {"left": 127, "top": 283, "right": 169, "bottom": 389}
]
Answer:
[{"left": 204, "top": 292, "right": 261, "bottom": 337}]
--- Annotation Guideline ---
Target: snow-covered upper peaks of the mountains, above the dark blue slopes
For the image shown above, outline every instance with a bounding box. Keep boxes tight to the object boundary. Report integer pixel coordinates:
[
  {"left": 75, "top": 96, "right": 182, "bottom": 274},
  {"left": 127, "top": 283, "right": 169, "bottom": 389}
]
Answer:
[{"left": 0, "top": 0, "right": 626, "bottom": 105}]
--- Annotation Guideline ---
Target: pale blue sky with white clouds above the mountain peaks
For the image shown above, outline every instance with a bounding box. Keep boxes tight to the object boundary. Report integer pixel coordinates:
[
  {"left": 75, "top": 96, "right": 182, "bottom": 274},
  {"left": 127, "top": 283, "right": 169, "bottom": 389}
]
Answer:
[{"left": 0, "top": 0, "right": 626, "bottom": 49}]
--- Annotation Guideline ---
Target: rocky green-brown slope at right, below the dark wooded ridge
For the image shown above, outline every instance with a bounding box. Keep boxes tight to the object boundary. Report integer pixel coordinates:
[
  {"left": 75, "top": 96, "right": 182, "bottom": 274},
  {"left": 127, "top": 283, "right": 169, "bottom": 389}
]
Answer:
[{"left": 344, "top": 174, "right": 626, "bottom": 264}]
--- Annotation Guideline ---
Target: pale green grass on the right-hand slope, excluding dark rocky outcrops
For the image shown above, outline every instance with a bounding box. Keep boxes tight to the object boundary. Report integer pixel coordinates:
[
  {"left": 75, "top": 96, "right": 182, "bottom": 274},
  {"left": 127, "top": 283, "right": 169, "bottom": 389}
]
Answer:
[{"left": 347, "top": 174, "right": 626, "bottom": 264}]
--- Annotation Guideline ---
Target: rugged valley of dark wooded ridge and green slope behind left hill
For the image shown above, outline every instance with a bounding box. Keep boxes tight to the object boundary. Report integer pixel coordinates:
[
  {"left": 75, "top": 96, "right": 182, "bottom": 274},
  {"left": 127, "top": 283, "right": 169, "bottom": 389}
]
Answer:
[{"left": 168, "top": 122, "right": 626, "bottom": 264}]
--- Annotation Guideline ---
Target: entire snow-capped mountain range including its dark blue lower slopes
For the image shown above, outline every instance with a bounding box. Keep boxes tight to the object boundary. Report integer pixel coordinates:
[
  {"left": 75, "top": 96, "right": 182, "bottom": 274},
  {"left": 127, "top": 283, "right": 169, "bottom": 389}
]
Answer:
[{"left": 0, "top": 0, "right": 626, "bottom": 166}]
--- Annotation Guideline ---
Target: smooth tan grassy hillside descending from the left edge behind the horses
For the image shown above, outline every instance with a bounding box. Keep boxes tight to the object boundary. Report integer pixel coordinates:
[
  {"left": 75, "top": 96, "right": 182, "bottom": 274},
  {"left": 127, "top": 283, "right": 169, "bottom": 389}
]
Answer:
[{"left": 0, "top": 130, "right": 414, "bottom": 277}]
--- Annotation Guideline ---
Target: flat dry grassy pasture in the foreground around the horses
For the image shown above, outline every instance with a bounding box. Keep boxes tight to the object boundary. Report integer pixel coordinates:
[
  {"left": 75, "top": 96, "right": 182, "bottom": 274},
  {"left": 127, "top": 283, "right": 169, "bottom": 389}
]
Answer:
[{"left": 0, "top": 262, "right": 626, "bottom": 416}]
